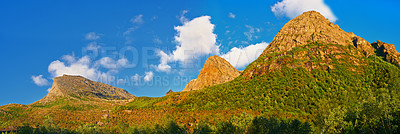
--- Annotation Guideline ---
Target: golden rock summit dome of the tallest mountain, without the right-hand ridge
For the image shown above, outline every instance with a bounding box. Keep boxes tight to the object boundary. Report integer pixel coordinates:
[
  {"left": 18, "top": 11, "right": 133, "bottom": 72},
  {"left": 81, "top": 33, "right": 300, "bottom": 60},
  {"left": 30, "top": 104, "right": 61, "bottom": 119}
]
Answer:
[{"left": 263, "top": 11, "right": 355, "bottom": 55}]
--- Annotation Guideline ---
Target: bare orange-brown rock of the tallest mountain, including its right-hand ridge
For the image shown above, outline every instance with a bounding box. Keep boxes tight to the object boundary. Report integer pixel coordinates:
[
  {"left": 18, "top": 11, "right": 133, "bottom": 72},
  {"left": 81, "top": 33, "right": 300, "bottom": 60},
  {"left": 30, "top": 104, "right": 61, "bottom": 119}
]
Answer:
[{"left": 243, "top": 11, "right": 400, "bottom": 78}]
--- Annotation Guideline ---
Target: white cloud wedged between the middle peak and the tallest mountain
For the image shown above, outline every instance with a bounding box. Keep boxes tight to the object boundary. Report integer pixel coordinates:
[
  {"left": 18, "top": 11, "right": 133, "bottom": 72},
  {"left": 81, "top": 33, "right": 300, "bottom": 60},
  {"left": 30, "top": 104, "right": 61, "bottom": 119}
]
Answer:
[{"left": 221, "top": 42, "right": 268, "bottom": 68}]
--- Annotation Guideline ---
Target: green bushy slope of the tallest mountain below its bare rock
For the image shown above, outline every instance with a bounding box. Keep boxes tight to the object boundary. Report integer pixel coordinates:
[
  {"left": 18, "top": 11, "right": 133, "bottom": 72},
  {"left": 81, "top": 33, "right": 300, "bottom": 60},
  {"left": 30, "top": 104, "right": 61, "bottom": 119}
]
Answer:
[{"left": 116, "top": 43, "right": 400, "bottom": 131}]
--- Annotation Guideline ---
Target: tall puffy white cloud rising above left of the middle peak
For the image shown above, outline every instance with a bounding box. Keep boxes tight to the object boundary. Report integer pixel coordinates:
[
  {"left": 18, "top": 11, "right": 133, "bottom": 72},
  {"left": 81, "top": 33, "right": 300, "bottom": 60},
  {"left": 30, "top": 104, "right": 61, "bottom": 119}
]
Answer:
[{"left": 158, "top": 16, "right": 219, "bottom": 71}]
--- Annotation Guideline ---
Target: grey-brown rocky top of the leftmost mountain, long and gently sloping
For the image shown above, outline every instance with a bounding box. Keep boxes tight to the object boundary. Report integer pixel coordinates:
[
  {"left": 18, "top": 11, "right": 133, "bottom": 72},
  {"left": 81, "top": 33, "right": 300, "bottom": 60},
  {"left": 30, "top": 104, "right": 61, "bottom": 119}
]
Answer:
[{"left": 38, "top": 75, "right": 136, "bottom": 102}]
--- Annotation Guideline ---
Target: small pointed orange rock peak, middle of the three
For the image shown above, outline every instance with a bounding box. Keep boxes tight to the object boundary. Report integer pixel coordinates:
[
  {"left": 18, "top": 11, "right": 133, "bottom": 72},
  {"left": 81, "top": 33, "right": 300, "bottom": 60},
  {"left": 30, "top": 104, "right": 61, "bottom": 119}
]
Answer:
[{"left": 183, "top": 55, "right": 240, "bottom": 91}]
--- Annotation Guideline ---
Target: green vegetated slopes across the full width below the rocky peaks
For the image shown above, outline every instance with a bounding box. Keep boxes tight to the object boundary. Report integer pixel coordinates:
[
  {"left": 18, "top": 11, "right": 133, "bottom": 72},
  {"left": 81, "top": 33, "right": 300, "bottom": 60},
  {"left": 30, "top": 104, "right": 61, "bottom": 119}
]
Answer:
[{"left": 0, "top": 43, "right": 400, "bottom": 133}]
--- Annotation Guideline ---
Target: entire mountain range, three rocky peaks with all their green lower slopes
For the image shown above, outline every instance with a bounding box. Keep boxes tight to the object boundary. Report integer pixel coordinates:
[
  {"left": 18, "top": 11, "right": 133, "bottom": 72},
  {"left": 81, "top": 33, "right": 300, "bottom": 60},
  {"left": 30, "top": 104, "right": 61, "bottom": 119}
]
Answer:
[{"left": 0, "top": 11, "right": 400, "bottom": 133}]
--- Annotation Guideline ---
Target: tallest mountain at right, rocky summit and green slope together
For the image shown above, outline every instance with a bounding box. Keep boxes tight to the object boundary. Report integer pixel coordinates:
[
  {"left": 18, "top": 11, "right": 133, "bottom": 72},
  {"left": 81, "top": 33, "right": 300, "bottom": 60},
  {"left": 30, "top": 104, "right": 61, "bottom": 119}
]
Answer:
[{"left": 121, "top": 11, "right": 400, "bottom": 133}]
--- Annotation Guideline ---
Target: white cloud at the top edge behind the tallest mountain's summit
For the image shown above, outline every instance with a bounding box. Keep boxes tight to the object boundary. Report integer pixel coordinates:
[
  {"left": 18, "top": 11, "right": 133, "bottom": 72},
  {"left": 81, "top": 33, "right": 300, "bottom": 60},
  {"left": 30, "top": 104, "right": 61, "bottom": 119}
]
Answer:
[{"left": 271, "top": 0, "right": 337, "bottom": 22}]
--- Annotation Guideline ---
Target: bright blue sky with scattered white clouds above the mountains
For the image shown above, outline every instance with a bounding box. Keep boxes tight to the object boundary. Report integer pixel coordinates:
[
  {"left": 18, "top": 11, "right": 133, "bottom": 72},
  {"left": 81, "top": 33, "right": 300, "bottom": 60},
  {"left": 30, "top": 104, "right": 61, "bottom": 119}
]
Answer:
[{"left": 0, "top": 0, "right": 400, "bottom": 105}]
